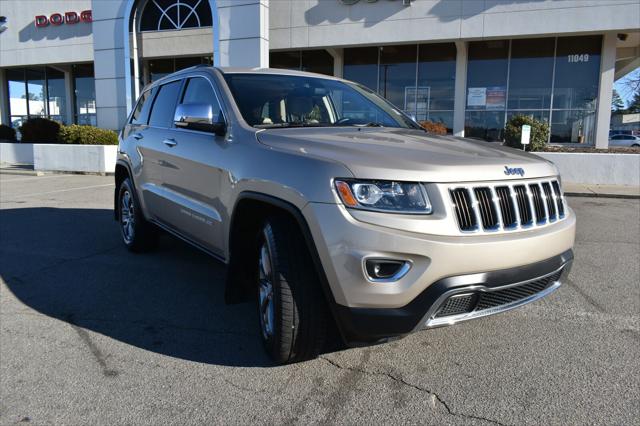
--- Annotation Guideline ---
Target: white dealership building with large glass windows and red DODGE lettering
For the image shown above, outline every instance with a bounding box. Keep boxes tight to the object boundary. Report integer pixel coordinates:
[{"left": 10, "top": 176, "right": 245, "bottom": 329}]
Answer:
[{"left": 0, "top": 0, "right": 640, "bottom": 147}]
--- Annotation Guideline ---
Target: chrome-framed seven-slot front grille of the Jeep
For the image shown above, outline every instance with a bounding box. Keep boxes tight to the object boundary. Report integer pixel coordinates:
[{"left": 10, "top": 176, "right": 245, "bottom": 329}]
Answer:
[{"left": 449, "top": 180, "right": 565, "bottom": 232}]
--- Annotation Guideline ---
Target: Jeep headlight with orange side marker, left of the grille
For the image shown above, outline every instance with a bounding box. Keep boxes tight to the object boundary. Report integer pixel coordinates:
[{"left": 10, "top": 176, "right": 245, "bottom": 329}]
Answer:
[{"left": 335, "top": 179, "right": 431, "bottom": 214}]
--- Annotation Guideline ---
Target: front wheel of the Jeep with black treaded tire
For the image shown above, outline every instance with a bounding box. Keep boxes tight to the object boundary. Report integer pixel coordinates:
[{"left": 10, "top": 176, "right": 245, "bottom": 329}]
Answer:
[{"left": 257, "top": 216, "right": 328, "bottom": 364}]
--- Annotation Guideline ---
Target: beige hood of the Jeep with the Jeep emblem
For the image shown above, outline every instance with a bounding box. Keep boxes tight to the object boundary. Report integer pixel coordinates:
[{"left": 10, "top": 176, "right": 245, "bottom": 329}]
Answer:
[{"left": 257, "top": 127, "right": 557, "bottom": 182}]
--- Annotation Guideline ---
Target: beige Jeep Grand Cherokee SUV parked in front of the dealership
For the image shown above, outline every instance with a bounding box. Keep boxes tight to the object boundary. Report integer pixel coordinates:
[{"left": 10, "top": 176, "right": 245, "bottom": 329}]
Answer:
[{"left": 115, "top": 67, "right": 575, "bottom": 363}]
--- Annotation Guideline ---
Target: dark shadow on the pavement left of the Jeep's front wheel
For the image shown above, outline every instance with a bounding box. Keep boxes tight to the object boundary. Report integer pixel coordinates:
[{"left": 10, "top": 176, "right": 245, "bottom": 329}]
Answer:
[{"left": 0, "top": 208, "right": 272, "bottom": 366}]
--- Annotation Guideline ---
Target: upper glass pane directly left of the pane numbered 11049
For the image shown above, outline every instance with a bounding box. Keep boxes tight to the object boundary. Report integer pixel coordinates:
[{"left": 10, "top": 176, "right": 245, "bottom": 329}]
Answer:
[{"left": 508, "top": 38, "right": 555, "bottom": 109}]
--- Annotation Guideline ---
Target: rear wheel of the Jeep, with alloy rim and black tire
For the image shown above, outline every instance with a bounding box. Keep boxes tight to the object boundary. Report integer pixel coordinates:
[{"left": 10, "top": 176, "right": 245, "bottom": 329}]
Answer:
[{"left": 117, "top": 178, "right": 157, "bottom": 253}]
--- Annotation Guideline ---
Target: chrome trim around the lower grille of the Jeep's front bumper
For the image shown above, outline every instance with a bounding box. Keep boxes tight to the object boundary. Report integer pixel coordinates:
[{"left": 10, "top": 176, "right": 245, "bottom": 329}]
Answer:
[{"left": 416, "top": 262, "right": 571, "bottom": 331}]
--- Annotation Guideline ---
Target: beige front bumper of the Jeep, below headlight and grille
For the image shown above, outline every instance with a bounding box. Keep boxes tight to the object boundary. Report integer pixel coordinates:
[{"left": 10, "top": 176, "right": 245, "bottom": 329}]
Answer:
[{"left": 303, "top": 203, "right": 575, "bottom": 343}]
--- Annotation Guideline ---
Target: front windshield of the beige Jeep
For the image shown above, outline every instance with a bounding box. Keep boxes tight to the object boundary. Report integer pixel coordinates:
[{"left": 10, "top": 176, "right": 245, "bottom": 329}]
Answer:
[{"left": 225, "top": 73, "right": 420, "bottom": 129}]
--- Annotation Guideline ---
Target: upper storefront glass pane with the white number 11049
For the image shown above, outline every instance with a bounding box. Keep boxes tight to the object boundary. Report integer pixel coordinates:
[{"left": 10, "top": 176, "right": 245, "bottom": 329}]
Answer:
[{"left": 553, "top": 36, "right": 602, "bottom": 110}]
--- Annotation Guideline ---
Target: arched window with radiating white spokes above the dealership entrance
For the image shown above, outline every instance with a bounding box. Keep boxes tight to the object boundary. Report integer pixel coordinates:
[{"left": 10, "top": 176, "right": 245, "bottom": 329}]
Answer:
[{"left": 140, "top": 0, "right": 212, "bottom": 31}]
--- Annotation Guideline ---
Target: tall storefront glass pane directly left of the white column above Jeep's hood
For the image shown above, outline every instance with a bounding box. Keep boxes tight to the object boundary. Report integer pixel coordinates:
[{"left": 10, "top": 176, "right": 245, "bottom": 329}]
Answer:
[{"left": 416, "top": 43, "right": 456, "bottom": 128}]
